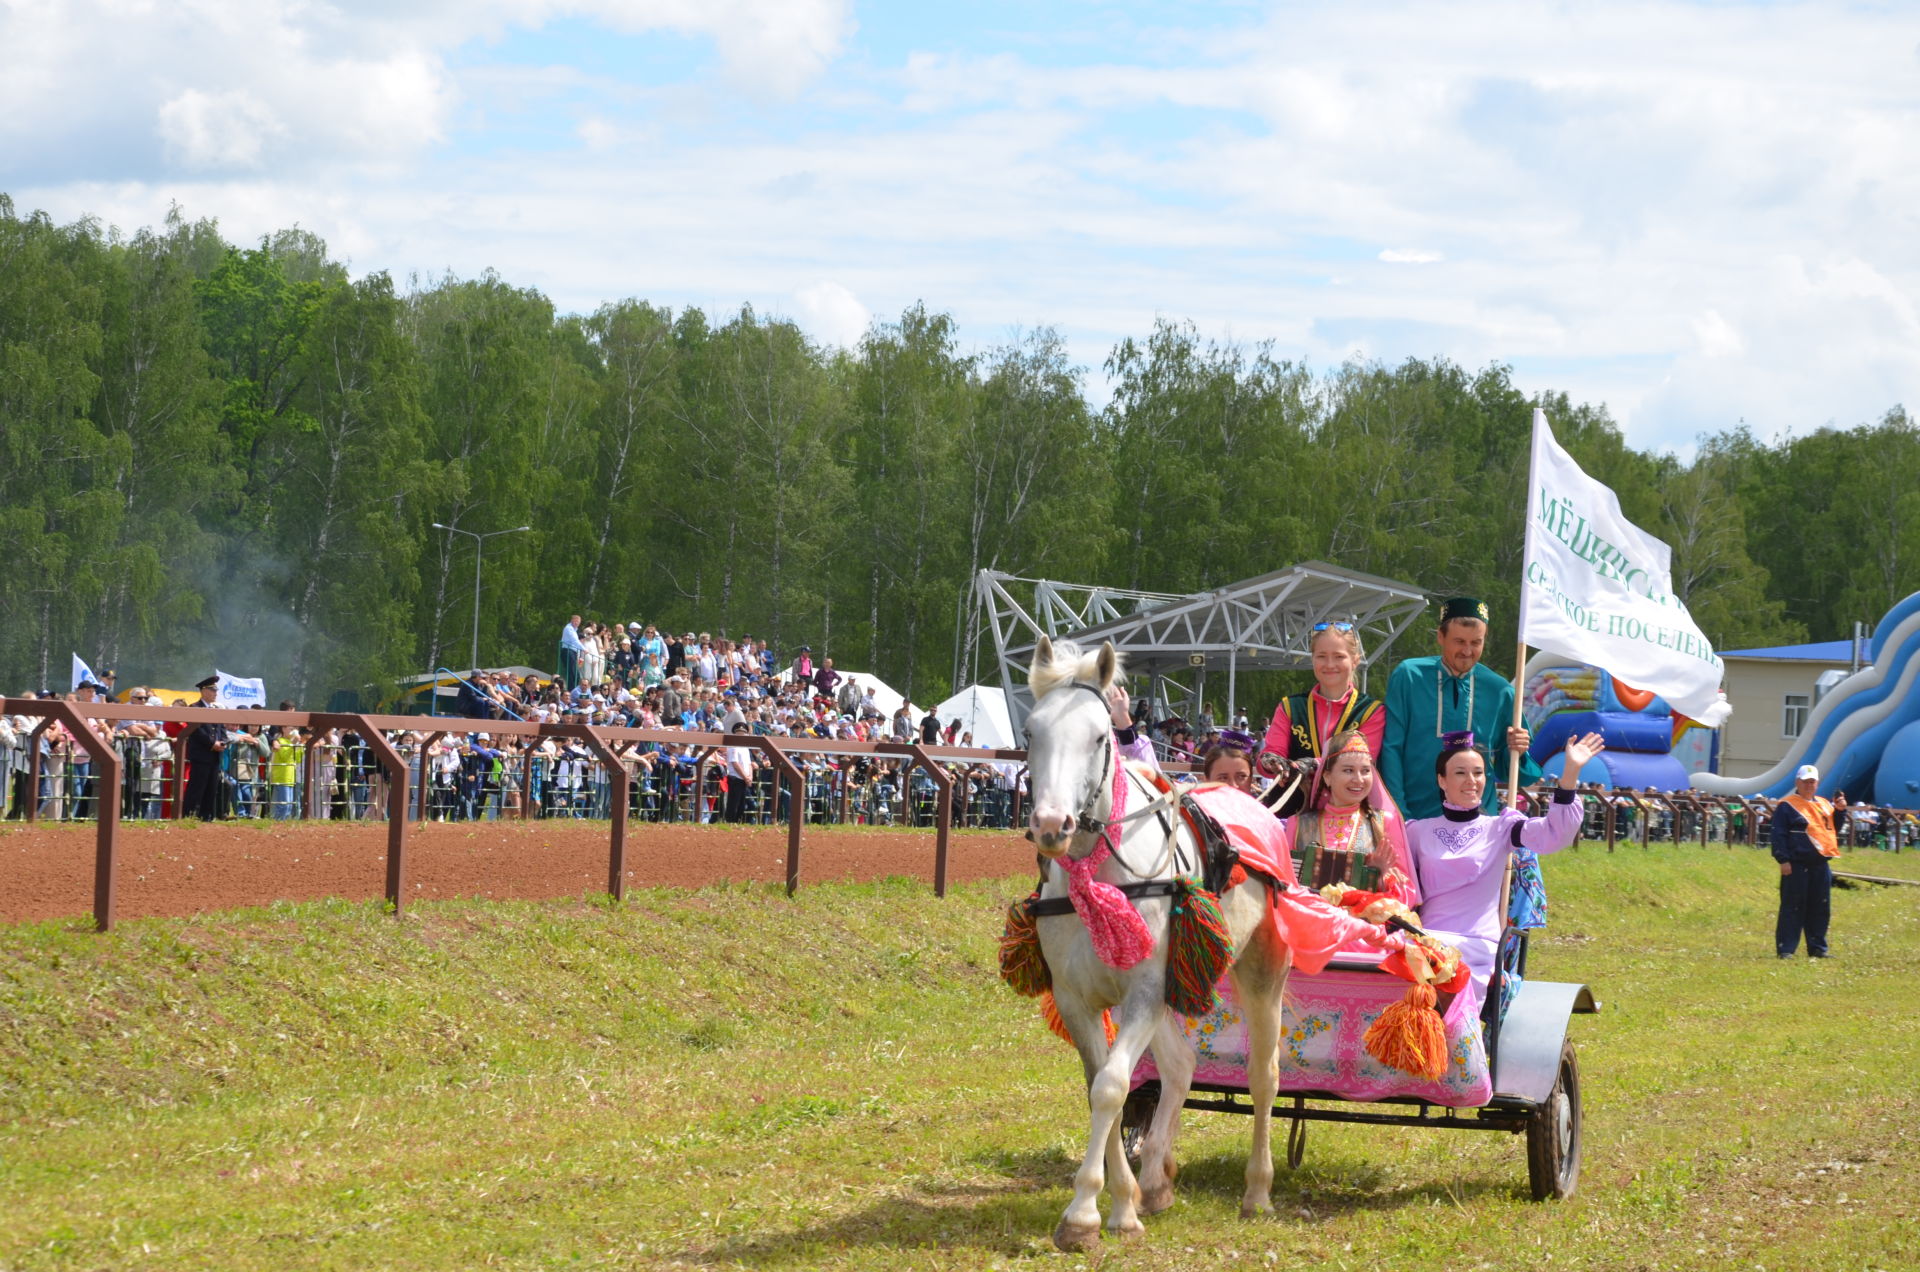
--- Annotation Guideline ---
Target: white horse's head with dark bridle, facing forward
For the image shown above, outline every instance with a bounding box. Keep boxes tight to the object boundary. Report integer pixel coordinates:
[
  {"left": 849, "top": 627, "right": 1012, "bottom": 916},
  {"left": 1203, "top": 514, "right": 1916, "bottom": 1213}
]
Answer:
[{"left": 1027, "top": 636, "right": 1119, "bottom": 857}]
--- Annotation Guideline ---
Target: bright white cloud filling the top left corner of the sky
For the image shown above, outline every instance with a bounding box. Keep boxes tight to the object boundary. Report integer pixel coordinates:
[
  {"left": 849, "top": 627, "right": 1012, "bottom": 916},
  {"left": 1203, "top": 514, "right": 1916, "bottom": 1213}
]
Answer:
[{"left": 0, "top": 0, "right": 852, "bottom": 184}]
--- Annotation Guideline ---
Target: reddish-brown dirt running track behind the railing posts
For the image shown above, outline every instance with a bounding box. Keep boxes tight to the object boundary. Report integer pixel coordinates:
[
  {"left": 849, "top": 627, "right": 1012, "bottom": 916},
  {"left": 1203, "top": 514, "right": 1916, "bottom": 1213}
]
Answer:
[{"left": 0, "top": 822, "right": 1033, "bottom": 922}]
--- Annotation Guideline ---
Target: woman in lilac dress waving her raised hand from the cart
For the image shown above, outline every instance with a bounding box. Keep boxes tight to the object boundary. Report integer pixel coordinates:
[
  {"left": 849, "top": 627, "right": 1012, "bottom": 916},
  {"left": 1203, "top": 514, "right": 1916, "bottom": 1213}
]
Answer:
[{"left": 1407, "top": 734, "right": 1605, "bottom": 1011}]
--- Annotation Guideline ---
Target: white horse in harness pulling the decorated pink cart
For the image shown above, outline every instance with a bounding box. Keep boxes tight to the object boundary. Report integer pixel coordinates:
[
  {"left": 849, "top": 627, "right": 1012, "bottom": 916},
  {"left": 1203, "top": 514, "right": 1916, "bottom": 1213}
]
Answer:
[{"left": 1027, "top": 636, "right": 1290, "bottom": 1251}]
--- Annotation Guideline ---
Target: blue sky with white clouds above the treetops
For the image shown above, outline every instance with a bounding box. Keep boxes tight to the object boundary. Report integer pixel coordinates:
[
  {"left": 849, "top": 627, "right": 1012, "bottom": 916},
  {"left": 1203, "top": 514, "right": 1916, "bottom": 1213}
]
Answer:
[{"left": 0, "top": 0, "right": 1920, "bottom": 455}]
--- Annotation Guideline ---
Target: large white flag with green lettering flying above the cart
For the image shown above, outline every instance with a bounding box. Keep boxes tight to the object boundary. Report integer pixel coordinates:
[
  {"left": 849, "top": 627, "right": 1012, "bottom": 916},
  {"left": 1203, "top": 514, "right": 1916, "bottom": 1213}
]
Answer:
[{"left": 1521, "top": 409, "right": 1732, "bottom": 726}]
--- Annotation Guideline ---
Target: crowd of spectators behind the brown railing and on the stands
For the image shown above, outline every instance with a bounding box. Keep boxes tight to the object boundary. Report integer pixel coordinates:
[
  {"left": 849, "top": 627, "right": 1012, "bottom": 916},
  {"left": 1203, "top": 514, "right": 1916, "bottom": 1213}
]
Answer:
[{"left": 26, "top": 615, "right": 1920, "bottom": 845}]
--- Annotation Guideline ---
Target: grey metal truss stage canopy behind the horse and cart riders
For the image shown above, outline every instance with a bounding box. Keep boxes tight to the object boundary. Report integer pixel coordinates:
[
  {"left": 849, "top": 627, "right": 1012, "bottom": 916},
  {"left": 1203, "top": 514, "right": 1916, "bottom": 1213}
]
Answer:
[{"left": 970, "top": 561, "right": 1427, "bottom": 730}]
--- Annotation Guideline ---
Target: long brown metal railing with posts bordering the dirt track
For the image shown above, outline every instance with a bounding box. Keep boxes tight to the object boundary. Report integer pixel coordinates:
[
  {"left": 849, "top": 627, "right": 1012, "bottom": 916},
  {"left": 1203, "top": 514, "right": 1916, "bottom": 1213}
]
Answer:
[{"left": 11, "top": 699, "right": 1920, "bottom": 930}]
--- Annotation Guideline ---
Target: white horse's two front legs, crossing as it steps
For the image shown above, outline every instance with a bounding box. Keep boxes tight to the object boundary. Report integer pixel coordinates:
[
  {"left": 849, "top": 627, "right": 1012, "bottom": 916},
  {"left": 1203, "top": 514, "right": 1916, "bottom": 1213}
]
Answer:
[{"left": 1054, "top": 980, "right": 1158, "bottom": 1251}]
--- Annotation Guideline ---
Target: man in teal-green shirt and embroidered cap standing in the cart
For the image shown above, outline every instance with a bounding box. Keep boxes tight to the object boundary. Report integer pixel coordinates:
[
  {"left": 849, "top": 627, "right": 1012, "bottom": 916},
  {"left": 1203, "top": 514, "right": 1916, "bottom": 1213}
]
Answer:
[{"left": 1380, "top": 596, "right": 1540, "bottom": 820}]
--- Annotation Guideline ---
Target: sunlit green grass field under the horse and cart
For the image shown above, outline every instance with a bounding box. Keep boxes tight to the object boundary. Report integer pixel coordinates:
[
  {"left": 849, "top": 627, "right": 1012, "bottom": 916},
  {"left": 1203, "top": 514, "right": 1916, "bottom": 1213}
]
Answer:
[{"left": 0, "top": 845, "right": 1920, "bottom": 1272}]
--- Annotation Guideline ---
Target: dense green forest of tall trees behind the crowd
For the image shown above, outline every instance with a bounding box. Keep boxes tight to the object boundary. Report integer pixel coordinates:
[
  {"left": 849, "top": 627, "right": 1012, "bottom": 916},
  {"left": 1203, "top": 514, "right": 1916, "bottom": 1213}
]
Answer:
[{"left": 0, "top": 194, "right": 1920, "bottom": 707}]
